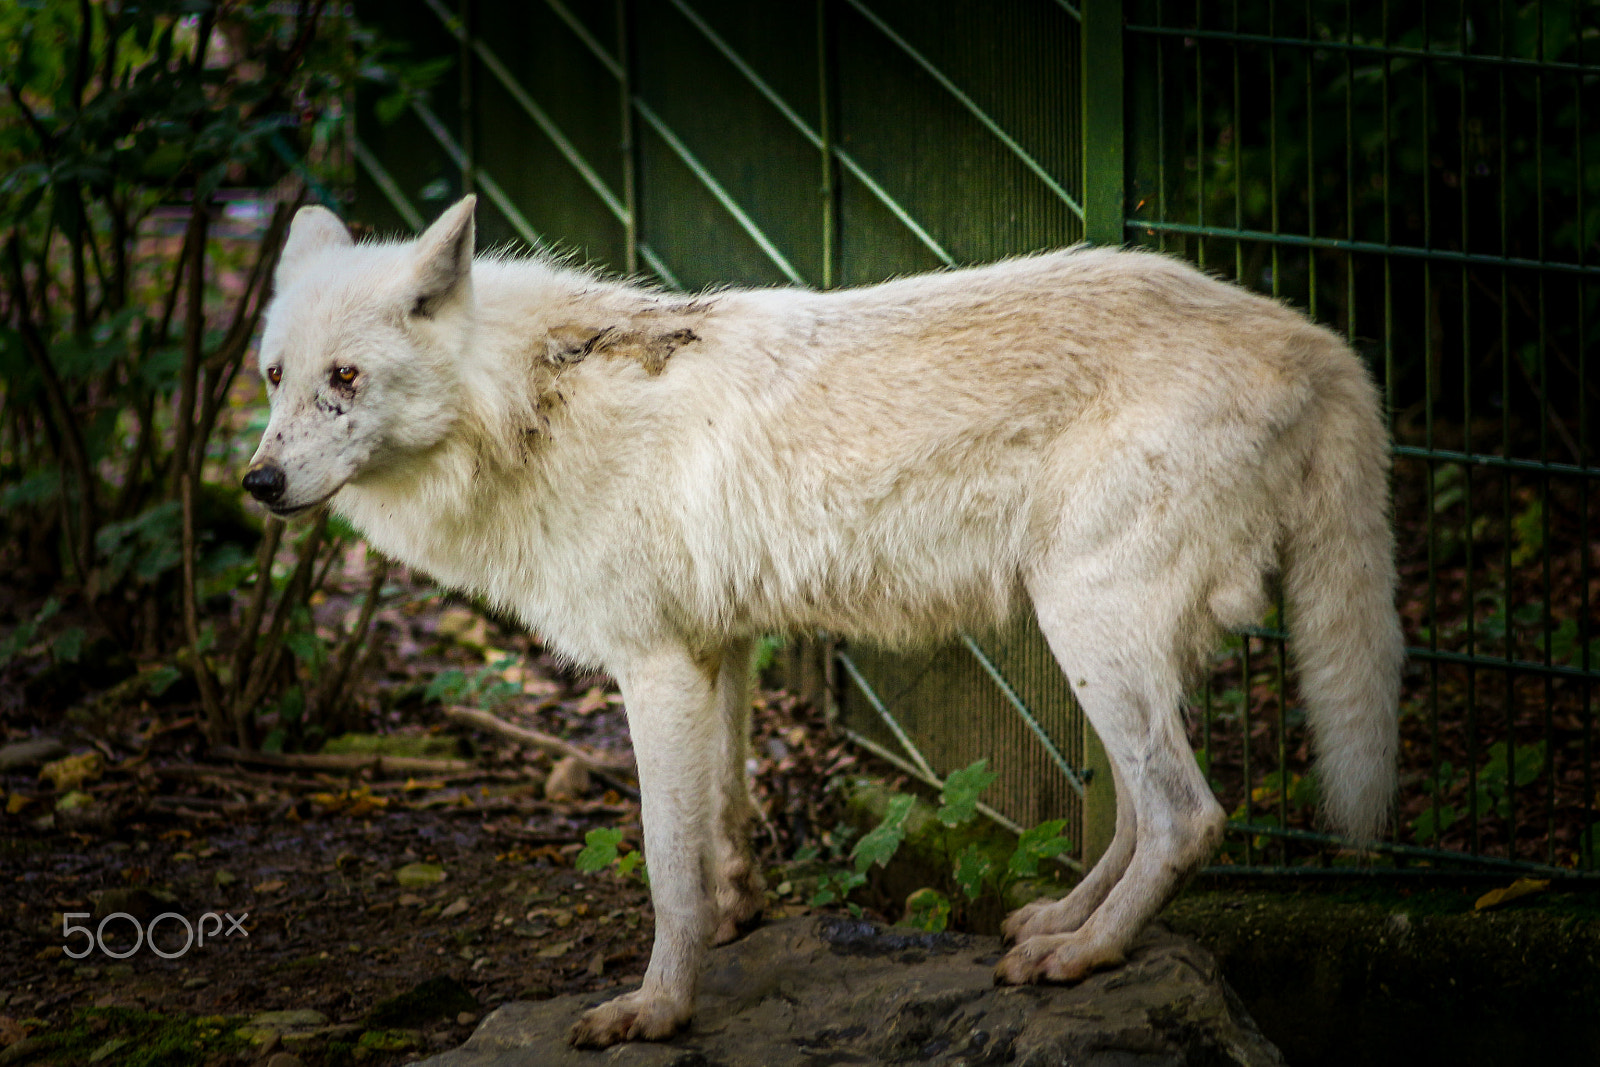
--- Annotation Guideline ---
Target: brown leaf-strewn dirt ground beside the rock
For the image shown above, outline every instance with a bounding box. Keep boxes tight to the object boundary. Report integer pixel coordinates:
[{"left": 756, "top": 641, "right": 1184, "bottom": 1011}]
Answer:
[{"left": 0, "top": 588, "right": 854, "bottom": 1067}]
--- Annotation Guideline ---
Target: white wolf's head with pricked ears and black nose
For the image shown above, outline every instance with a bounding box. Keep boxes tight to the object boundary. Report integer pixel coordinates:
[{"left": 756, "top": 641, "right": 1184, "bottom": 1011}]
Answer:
[{"left": 245, "top": 197, "right": 475, "bottom": 517}]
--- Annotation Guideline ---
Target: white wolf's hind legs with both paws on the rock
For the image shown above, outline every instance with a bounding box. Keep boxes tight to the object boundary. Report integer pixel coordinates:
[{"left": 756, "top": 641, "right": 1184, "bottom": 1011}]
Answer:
[{"left": 995, "top": 568, "right": 1226, "bottom": 982}]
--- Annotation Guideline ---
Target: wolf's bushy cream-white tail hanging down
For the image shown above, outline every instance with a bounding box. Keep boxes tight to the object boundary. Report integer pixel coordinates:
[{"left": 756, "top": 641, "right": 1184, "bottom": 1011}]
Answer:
[{"left": 1283, "top": 366, "right": 1405, "bottom": 841}]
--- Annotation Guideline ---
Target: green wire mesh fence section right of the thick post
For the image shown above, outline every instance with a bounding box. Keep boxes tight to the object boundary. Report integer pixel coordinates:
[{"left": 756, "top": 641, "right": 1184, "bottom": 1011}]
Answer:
[{"left": 1125, "top": 0, "right": 1600, "bottom": 870}]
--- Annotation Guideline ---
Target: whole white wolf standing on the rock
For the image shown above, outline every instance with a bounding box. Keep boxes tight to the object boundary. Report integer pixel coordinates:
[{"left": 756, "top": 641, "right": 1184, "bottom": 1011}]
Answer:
[{"left": 245, "top": 197, "right": 1402, "bottom": 1046}]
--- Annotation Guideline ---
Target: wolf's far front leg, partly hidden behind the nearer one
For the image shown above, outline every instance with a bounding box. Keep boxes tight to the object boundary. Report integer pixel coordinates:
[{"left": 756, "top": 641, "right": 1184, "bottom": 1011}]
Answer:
[{"left": 712, "top": 640, "right": 766, "bottom": 945}]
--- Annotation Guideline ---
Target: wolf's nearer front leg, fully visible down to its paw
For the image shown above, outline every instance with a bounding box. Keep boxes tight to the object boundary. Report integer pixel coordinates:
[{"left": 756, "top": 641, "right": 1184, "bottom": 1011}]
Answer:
[{"left": 568, "top": 649, "right": 718, "bottom": 1048}]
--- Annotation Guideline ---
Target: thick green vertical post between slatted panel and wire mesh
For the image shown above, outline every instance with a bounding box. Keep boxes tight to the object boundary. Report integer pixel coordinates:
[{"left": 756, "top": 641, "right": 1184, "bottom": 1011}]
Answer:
[{"left": 1080, "top": 0, "right": 1126, "bottom": 870}]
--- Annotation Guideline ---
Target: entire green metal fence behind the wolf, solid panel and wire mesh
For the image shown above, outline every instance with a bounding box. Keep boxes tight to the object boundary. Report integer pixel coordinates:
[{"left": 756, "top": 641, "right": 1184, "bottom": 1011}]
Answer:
[{"left": 355, "top": 0, "right": 1600, "bottom": 872}]
